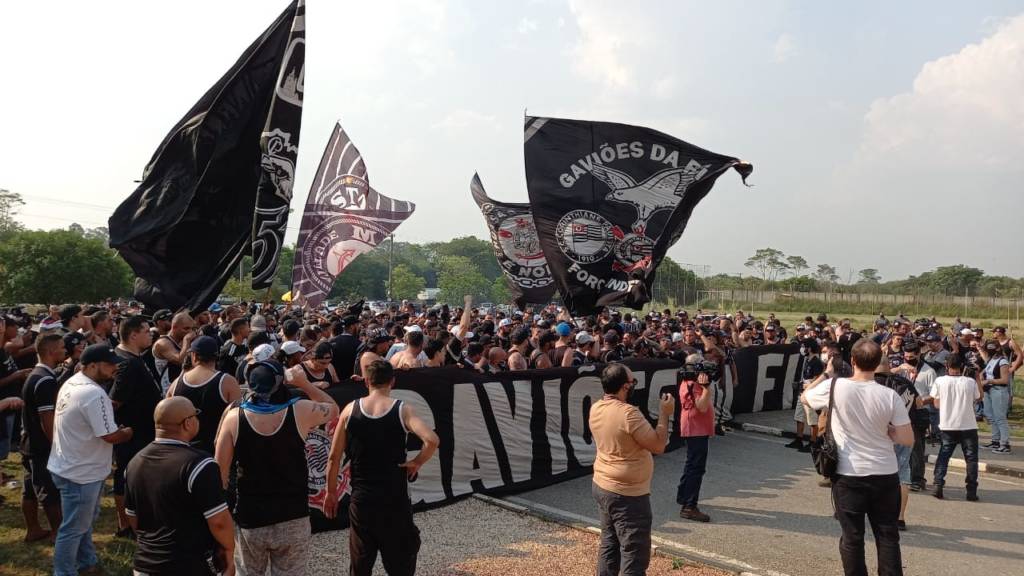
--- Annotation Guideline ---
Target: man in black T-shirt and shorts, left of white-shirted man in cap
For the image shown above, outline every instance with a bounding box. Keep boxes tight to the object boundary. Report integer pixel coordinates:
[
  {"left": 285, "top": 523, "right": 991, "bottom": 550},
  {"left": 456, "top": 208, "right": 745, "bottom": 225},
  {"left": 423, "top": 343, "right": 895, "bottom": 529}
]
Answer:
[{"left": 22, "top": 332, "right": 66, "bottom": 542}]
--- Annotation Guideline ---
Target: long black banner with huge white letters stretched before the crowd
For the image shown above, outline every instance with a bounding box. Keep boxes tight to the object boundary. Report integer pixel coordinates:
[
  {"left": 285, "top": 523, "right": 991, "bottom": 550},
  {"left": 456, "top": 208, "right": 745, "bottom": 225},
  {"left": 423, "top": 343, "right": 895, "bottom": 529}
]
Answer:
[{"left": 306, "top": 344, "right": 799, "bottom": 530}]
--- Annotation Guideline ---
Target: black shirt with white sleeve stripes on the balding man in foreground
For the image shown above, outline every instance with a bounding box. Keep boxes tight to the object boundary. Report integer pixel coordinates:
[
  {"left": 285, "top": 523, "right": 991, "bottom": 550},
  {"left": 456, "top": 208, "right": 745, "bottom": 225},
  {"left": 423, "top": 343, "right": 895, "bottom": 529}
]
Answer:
[{"left": 125, "top": 440, "right": 227, "bottom": 575}]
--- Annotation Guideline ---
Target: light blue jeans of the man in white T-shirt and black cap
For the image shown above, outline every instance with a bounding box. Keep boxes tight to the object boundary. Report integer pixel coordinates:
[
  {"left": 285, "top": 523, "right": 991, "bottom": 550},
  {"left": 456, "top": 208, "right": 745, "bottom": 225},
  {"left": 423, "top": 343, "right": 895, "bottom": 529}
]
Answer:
[{"left": 51, "top": 474, "right": 103, "bottom": 576}]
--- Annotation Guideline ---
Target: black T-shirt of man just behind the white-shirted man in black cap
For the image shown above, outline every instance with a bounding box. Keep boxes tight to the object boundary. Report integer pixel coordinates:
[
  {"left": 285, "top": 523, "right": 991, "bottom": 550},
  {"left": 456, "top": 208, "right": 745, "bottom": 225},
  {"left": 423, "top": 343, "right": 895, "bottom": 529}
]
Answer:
[{"left": 111, "top": 348, "right": 164, "bottom": 447}]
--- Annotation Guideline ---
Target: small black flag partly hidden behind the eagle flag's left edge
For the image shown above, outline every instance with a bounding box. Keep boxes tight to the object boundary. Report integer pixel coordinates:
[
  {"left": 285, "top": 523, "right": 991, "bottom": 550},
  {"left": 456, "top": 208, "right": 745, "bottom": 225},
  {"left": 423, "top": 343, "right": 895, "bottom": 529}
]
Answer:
[{"left": 469, "top": 174, "right": 555, "bottom": 310}]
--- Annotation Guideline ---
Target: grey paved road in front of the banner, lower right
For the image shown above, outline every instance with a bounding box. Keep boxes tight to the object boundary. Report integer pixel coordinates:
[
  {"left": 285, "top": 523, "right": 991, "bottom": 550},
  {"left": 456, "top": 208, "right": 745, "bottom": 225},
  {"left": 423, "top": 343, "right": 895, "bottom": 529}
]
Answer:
[{"left": 518, "top": 431, "right": 1024, "bottom": 576}]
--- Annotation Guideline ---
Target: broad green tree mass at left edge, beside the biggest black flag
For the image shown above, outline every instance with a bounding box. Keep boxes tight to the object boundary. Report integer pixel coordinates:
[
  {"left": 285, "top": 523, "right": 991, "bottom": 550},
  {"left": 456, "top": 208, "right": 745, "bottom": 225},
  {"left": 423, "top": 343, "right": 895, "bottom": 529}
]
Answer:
[{"left": 0, "top": 230, "right": 134, "bottom": 303}]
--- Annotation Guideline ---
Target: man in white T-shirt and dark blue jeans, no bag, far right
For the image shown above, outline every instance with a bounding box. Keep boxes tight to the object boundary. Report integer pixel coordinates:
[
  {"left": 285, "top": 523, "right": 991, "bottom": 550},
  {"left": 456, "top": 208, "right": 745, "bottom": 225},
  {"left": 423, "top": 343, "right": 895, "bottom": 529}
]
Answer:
[{"left": 932, "top": 354, "right": 981, "bottom": 501}]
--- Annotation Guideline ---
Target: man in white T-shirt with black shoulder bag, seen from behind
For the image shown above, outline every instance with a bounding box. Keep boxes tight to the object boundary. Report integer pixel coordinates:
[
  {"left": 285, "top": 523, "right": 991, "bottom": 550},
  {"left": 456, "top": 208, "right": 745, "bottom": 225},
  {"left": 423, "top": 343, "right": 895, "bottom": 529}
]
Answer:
[{"left": 803, "top": 338, "right": 913, "bottom": 576}]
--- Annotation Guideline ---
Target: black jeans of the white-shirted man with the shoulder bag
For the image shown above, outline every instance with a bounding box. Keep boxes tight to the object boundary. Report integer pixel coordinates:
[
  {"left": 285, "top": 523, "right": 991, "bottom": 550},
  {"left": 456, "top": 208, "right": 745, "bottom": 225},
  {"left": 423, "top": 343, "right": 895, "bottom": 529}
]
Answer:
[{"left": 833, "top": 474, "right": 903, "bottom": 576}]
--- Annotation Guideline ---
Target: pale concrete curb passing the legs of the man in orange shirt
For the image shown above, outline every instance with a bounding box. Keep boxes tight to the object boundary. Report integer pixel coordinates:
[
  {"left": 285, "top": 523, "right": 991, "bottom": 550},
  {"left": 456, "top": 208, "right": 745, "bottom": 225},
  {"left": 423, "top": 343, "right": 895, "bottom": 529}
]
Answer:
[{"left": 473, "top": 487, "right": 788, "bottom": 576}]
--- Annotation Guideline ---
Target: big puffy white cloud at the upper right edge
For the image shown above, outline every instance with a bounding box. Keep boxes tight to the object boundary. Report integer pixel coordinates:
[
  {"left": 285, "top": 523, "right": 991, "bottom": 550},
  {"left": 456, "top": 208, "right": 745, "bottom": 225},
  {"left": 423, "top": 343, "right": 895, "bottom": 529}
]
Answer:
[{"left": 859, "top": 14, "right": 1024, "bottom": 172}]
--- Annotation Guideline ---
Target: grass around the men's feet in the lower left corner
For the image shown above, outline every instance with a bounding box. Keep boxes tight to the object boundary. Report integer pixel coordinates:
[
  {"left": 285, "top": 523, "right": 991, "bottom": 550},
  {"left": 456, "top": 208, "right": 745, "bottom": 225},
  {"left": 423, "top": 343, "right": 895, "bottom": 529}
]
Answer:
[{"left": 0, "top": 453, "right": 135, "bottom": 576}]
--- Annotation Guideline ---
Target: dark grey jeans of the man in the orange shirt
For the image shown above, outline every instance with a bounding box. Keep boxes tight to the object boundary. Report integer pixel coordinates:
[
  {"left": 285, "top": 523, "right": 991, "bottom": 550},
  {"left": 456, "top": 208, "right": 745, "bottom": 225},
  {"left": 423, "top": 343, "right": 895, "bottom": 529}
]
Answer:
[{"left": 591, "top": 484, "right": 651, "bottom": 576}]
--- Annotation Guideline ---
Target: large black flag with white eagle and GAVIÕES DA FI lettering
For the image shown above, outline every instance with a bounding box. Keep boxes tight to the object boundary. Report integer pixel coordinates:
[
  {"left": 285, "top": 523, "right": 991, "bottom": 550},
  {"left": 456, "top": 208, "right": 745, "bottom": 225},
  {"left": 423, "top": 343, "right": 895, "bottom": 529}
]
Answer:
[{"left": 524, "top": 117, "right": 753, "bottom": 316}]
